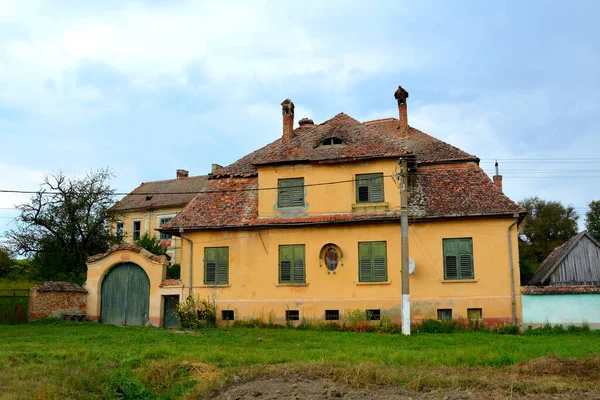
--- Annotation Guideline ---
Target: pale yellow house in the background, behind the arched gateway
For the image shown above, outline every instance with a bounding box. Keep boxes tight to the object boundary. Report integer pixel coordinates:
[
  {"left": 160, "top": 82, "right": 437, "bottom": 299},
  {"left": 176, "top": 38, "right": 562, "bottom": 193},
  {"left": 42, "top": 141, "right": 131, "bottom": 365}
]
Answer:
[{"left": 110, "top": 169, "right": 208, "bottom": 264}]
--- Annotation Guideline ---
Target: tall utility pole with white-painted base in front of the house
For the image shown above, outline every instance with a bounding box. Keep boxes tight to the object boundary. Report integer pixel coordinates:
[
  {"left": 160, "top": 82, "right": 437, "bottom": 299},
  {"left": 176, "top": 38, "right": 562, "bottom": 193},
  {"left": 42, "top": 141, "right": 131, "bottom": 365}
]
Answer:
[{"left": 399, "top": 158, "right": 410, "bottom": 336}]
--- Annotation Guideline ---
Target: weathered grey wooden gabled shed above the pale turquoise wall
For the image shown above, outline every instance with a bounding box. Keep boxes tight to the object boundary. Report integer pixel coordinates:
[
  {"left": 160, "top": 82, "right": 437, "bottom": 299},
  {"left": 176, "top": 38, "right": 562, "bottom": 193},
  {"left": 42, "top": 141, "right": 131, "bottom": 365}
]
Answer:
[{"left": 528, "top": 231, "right": 600, "bottom": 286}]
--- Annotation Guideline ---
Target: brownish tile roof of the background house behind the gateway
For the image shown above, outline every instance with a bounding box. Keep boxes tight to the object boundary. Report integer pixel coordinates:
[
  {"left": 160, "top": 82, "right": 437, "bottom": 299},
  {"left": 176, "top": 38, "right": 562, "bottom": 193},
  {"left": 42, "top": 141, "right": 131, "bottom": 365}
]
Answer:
[{"left": 111, "top": 175, "right": 208, "bottom": 212}]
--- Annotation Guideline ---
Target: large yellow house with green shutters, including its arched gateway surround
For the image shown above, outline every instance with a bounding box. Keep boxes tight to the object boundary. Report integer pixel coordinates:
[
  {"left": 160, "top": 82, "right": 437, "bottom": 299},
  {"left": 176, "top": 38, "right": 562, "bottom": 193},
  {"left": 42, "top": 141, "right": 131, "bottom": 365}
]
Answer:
[{"left": 88, "top": 84, "right": 525, "bottom": 325}]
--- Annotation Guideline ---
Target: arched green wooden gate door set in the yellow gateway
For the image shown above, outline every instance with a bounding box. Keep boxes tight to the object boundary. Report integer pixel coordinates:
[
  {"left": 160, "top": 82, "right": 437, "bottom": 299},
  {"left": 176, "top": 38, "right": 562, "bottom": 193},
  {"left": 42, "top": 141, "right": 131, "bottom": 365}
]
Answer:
[{"left": 100, "top": 263, "right": 150, "bottom": 326}]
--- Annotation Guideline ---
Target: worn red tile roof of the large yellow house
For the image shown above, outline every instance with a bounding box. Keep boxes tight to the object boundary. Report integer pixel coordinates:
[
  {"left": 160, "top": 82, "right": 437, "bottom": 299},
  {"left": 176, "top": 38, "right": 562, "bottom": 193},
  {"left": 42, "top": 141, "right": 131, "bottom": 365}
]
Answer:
[{"left": 163, "top": 114, "right": 523, "bottom": 233}]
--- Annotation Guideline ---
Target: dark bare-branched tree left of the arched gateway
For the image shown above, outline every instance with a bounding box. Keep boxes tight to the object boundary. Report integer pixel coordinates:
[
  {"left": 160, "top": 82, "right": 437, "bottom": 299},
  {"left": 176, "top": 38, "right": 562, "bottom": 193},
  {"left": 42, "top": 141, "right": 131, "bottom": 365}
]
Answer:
[{"left": 6, "top": 169, "right": 119, "bottom": 283}]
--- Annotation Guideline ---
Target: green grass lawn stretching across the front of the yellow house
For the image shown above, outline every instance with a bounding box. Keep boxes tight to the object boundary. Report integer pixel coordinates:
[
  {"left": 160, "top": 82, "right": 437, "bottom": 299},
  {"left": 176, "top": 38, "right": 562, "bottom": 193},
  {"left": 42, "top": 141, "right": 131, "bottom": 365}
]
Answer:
[{"left": 0, "top": 322, "right": 600, "bottom": 399}]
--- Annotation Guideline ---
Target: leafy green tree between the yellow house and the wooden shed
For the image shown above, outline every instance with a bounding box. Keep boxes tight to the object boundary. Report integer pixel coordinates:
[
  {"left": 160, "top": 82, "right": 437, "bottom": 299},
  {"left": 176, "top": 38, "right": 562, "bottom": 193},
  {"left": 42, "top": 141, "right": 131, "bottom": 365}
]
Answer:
[{"left": 519, "top": 197, "right": 579, "bottom": 284}]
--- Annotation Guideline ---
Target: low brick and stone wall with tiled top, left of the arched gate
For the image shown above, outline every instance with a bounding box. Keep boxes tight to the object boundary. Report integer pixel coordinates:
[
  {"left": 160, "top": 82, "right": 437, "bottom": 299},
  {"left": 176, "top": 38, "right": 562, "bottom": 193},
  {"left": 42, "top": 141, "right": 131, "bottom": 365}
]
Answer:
[{"left": 29, "top": 282, "right": 87, "bottom": 321}]
